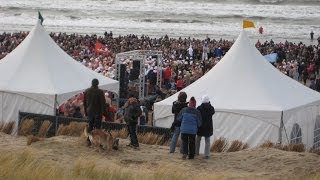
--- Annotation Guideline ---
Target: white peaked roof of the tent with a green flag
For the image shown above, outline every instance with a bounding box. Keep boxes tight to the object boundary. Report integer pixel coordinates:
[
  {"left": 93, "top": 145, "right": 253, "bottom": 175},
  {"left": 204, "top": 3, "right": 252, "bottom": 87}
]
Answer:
[{"left": 0, "top": 22, "right": 118, "bottom": 104}]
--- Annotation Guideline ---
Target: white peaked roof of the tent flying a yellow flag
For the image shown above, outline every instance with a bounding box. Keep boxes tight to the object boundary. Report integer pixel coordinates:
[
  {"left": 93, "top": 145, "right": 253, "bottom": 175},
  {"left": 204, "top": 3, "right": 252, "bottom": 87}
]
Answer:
[{"left": 157, "top": 30, "right": 320, "bottom": 111}]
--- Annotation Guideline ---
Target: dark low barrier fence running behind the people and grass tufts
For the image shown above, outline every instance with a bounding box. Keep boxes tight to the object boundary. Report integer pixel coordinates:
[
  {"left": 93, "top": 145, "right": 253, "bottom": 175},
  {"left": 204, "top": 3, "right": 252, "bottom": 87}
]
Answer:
[{"left": 18, "top": 112, "right": 171, "bottom": 142}]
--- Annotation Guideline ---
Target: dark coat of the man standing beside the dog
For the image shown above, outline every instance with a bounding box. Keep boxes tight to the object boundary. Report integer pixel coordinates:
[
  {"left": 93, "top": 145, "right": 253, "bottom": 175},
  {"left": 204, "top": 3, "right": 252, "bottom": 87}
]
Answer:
[{"left": 83, "top": 87, "right": 107, "bottom": 116}]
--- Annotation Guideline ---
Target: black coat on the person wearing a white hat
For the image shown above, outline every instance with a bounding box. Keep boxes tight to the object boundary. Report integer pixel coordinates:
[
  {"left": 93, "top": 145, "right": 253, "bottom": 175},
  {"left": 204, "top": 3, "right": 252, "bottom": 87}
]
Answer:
[{"left": 197, "top": 102, "right": 215, "bottom": 137}]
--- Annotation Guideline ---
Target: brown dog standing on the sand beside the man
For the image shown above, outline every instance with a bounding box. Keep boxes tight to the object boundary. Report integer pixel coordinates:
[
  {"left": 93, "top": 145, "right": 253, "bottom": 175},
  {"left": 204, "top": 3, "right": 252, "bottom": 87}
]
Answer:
[{"left": 84, "top": 126, "right": 119, "bottom": 151}]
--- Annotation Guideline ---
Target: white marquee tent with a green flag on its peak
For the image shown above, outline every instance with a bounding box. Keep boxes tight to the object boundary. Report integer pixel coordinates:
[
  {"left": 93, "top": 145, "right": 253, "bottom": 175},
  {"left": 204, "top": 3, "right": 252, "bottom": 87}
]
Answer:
[{"left": 0, "top": 22, "right": 119, "bottom": 123}]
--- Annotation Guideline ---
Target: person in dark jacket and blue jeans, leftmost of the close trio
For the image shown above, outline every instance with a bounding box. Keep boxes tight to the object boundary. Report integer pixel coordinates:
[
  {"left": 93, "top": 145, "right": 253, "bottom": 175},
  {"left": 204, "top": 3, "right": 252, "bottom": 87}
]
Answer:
[{"left": 170, "top": 92, "right": 188, "bottom": 153}]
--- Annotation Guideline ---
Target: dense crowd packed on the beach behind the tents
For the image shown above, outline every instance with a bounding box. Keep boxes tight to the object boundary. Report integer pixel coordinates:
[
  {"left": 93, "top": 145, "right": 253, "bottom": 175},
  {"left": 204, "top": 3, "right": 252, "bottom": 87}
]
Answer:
[{"left": 0, "top": 32, "right": 320, "bottom": 120}]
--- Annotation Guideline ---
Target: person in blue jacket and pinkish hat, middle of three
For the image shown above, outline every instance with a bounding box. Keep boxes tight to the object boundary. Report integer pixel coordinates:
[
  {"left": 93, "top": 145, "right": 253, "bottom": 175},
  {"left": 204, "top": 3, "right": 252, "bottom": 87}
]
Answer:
[{"left": 177, "top": 97, "right": 202, "bottom": 159}]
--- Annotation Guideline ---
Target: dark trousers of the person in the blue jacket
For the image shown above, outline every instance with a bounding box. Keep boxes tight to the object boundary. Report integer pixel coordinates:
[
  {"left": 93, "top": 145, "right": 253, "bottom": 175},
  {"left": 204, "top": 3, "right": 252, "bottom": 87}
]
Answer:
[{"left": 181, "top": 133, "right": 196, "bottom": 158}]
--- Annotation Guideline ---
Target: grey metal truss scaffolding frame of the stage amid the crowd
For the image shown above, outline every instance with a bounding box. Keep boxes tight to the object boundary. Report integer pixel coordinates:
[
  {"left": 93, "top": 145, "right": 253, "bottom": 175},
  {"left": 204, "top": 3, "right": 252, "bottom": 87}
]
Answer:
[{"left": 116, "top": 50, "right": 163, "bottom": 99}]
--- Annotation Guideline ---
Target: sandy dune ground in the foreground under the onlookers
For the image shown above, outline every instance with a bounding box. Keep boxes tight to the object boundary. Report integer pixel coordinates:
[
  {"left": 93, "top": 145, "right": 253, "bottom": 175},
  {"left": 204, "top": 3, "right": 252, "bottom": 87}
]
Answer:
[{"left": 0, "top": 133, "right": 320, "bottom": 179}]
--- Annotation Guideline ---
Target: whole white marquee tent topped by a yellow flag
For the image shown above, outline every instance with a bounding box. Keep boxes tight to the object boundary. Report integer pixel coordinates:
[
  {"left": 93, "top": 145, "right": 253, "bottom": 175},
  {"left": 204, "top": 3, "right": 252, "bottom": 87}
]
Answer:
[{"left": 154, "top": 30, "right": 320, "bottom": 147}]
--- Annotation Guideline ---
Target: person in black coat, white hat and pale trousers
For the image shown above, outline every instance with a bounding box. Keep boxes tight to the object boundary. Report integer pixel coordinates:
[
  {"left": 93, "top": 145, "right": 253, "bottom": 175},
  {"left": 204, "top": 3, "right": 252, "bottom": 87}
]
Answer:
[{"left": 196, "top": 95, "right": 215, "bottom": 159}]
